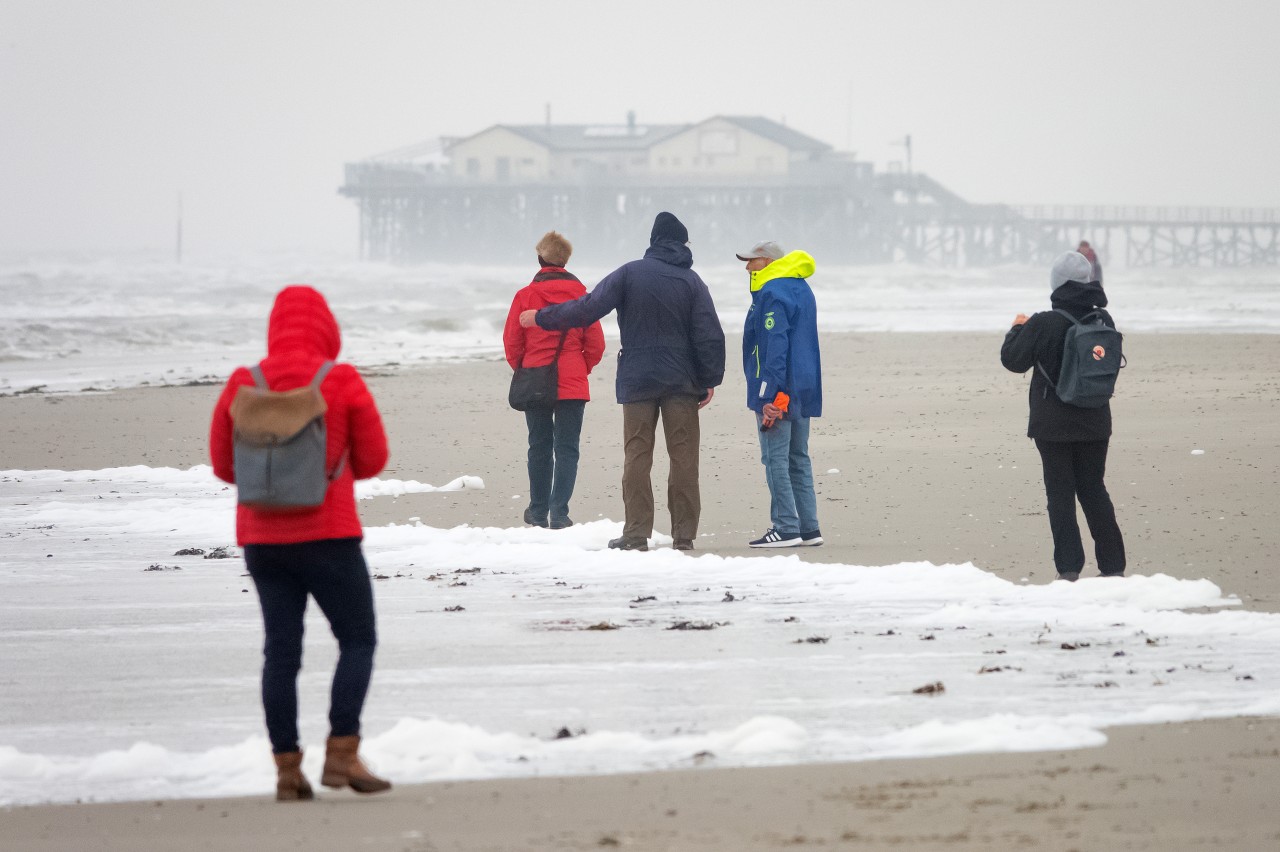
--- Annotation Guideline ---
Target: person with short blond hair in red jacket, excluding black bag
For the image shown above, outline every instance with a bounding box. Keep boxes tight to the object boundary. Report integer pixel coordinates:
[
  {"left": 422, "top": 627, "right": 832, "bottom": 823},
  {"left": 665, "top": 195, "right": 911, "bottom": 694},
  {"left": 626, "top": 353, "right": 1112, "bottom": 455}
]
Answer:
[{"left": 502, "top": 230, "right": 604, "bottom": 530}]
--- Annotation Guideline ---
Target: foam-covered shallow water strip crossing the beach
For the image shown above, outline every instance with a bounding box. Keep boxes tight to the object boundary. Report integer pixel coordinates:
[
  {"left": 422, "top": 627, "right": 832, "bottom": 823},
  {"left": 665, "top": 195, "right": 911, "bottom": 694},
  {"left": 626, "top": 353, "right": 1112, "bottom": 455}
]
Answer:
[{"left": 0, "top": 466, "right": 1280, "bottom": 803}]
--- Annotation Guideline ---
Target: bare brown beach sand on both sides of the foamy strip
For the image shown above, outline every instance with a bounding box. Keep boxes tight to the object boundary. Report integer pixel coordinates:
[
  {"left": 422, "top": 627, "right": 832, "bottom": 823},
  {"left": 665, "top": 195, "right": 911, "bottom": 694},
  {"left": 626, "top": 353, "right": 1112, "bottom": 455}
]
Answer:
[{"left": 0, "top": 330, "right": 1280, "bottom": 851}]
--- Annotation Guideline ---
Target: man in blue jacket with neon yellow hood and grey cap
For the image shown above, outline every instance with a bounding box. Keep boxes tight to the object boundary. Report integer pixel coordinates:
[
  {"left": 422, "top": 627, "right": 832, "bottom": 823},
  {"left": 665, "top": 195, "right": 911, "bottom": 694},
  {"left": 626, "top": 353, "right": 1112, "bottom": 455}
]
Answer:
[{"left": 737, "top": 241, "right": 822, "bottom": 548}]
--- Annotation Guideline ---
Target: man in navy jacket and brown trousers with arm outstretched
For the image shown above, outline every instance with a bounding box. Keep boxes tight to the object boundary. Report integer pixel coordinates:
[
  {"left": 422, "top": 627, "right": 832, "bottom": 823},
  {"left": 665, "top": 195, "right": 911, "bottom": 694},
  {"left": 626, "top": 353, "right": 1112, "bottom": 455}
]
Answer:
[{"left": 520, "top": 212, "right": 724, "bottom": 550}]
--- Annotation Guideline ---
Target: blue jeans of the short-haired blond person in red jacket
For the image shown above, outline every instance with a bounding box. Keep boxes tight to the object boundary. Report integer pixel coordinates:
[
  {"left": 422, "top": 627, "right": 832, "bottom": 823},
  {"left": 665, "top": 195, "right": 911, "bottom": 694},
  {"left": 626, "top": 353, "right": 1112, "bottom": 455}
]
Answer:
[{"left": 525, "top": 399, "right": 586, "bottom": 521}]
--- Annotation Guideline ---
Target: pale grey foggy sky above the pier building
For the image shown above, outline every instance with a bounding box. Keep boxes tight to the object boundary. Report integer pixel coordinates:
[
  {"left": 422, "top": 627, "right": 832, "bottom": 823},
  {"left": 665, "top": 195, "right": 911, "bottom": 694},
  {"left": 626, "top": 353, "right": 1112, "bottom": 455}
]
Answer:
[{"left": 0, "top": 0, "right": 1280, "bottom": 255}]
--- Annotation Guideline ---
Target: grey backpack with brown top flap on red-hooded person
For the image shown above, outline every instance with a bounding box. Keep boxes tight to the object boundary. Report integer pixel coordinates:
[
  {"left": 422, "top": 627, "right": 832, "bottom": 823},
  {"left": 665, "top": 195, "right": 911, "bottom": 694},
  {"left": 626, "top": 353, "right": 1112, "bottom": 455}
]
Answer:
[{"left": 230, "top": 361, "right": 346, "bottom": 512}]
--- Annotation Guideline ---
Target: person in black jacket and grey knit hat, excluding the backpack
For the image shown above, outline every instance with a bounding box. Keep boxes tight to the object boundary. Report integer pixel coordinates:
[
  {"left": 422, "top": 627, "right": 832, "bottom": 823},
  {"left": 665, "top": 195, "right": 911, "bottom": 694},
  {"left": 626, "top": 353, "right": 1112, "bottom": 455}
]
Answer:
[{"left": 1000, "top": 252, "right": 1125, "bottom": 581}]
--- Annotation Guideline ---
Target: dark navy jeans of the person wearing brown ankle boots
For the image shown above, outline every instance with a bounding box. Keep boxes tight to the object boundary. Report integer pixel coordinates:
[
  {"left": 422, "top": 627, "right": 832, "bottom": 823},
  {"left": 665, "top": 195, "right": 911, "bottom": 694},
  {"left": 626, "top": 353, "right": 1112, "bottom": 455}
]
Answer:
[{"left": 244, "top": 539, "right": 378, "bottom": 755}]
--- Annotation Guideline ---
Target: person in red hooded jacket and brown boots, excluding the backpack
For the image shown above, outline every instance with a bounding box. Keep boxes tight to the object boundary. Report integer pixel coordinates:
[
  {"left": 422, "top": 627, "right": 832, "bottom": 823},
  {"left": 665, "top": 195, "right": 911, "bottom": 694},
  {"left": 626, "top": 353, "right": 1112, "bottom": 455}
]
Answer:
[{"left": 209, "top": 285, "right": 390, "bottom": 801}]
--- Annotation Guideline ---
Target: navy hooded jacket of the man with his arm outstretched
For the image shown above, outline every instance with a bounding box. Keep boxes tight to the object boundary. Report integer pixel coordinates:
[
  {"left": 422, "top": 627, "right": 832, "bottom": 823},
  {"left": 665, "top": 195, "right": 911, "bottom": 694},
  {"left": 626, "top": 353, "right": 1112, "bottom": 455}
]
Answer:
[{"left": 538, "top": 235, "right": 724, "bottom": 404}]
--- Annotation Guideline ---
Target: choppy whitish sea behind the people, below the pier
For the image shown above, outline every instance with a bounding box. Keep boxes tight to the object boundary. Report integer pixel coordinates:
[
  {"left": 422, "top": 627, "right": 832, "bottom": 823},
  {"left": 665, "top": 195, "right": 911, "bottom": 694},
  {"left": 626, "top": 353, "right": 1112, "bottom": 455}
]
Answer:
[{"left": 0, "top": 256, "right": 1280, "bottom": 394}]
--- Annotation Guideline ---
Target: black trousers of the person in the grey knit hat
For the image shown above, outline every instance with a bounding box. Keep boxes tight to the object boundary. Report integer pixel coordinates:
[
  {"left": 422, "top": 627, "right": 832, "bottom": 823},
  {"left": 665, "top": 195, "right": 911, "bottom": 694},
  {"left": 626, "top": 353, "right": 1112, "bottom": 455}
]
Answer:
[{"left": 1036, "top": 439, "right": 1125, "bottom": 576}]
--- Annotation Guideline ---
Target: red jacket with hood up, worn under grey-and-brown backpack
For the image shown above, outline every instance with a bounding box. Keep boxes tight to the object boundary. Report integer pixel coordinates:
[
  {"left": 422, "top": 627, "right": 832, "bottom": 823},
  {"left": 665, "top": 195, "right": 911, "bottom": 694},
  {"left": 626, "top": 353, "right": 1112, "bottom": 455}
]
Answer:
[{"left": 209, "top": 285, "right": 387, "bottom": 545}]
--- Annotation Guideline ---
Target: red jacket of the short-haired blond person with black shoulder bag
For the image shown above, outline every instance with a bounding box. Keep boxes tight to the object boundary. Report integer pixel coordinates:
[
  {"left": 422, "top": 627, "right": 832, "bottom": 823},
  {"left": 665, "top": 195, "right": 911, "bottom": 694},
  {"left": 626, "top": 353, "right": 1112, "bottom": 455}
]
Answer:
[{"left": 502, "top": 266, "right": 604, "bottom": 399}]
